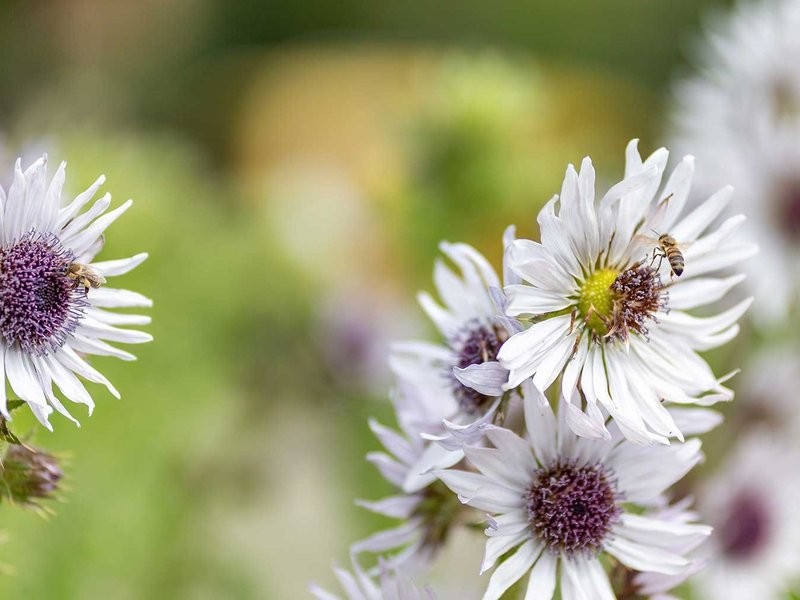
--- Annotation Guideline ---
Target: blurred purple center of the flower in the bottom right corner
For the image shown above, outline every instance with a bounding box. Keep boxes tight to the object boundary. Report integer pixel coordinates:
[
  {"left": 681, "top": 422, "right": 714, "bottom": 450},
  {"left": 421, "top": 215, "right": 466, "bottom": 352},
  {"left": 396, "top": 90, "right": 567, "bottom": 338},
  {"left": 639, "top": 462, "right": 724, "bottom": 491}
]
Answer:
[{"left": 717, "top": 492, "right": 771, "bottom": 560}]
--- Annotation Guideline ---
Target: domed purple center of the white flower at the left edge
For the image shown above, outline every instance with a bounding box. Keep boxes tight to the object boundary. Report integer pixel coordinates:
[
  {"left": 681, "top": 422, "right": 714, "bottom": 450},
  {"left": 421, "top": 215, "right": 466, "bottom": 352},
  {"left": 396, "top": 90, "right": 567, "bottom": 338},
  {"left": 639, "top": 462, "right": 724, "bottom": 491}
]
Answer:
[{"left": 0, "top": 231, "right": 87, "bottom": 356}]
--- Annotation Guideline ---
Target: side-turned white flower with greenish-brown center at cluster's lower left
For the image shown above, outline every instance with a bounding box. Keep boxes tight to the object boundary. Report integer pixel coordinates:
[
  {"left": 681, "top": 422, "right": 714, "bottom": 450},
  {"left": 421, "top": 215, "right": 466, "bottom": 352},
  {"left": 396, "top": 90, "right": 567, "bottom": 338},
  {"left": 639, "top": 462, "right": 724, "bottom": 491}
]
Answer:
[{"left": 350, "top": 380, "right": 476, "bottom": 571}]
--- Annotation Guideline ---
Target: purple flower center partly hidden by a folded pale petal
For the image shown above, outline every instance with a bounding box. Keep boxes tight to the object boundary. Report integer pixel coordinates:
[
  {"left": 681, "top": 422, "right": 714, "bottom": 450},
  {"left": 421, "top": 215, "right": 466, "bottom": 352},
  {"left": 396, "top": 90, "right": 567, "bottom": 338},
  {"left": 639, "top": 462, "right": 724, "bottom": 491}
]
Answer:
[{"left": 448, "top": 321, "right": 508, "bottom": 415}]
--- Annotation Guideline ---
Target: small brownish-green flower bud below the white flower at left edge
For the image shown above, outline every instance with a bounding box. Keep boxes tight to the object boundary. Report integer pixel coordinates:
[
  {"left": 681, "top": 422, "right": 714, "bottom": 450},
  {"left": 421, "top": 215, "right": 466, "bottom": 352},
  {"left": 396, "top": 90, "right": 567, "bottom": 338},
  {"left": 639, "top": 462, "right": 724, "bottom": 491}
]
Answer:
[{"left": 0, "top": 444, "right": 64, "bottom": 508}]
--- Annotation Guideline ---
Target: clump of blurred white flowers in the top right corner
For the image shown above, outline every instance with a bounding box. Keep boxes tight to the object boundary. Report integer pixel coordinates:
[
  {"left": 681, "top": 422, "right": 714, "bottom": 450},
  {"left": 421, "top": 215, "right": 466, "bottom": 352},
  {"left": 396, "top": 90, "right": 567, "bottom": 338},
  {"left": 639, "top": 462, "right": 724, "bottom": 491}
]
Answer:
[{"left": 672, "top": 0, "right": 800, "bottom": 323}]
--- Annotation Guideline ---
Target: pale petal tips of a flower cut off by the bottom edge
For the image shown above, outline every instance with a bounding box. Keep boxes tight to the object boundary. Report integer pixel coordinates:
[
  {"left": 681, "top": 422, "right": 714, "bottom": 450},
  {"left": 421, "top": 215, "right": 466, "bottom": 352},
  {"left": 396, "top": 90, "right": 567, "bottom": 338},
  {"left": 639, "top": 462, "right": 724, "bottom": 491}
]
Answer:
[{"left": 309, "top": 560, "right": 436, "bottom": 600}]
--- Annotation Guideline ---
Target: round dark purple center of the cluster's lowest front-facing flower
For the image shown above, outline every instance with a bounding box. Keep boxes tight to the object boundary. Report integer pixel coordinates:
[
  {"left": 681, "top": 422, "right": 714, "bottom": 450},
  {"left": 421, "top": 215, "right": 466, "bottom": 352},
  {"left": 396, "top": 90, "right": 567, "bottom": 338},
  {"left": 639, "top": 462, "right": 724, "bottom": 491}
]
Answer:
[{"left": 526, "top": 464, "right": 621, "bottom": 554}]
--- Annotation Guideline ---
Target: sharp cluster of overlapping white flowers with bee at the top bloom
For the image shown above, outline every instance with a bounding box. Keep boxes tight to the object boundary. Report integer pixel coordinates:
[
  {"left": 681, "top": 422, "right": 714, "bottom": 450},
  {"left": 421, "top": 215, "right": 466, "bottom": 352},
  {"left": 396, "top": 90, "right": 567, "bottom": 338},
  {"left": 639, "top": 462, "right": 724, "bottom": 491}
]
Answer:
[{"left": 315, "top": 141, "right": 756, "bottom": 600}]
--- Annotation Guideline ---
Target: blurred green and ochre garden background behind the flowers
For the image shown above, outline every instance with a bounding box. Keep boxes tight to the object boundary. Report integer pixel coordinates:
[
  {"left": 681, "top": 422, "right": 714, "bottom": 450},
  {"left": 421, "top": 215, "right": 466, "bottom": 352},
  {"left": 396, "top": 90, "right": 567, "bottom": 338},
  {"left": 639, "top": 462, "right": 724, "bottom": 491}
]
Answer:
[{"left": 0, "top": 0, "right": 732, "bottom": 599}]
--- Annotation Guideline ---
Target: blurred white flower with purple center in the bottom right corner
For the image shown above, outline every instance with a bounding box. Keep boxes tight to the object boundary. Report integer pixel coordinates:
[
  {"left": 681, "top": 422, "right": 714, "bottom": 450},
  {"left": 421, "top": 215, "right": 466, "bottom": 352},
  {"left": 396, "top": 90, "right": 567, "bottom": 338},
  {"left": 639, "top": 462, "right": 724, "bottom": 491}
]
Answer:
[{"left": 692, "top": 430, "right": 800, "bottom": 600}]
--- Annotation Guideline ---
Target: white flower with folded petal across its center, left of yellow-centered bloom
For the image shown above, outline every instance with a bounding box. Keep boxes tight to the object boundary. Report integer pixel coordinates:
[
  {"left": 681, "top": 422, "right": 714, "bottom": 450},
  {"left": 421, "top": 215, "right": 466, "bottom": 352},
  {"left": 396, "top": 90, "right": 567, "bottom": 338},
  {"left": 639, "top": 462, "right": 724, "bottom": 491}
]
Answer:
[{"left": 390, "top": 228, "right": 522, "bottom": 492}]
